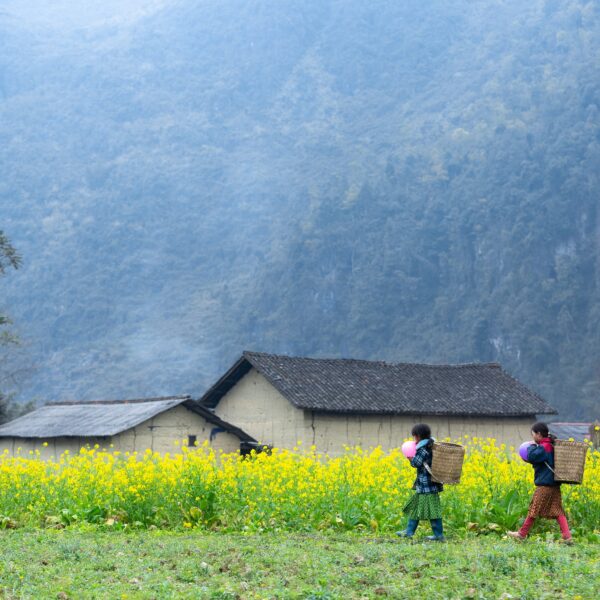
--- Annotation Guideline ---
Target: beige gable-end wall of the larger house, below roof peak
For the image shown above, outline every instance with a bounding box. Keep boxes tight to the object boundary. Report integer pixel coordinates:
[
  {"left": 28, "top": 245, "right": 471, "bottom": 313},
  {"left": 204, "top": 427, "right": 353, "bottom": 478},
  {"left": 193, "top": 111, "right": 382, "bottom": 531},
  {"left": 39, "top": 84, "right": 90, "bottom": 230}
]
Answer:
[{"left": 215, "top": 369, "right": 309, "bottom": 448}]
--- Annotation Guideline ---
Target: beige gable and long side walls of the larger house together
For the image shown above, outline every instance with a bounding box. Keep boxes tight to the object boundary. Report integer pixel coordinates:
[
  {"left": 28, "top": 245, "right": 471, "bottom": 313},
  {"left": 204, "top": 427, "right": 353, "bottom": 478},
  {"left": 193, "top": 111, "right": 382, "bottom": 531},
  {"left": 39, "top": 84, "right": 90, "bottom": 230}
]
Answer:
[{"left": 215, "top": 369, "right": 535, "bottom": 454}]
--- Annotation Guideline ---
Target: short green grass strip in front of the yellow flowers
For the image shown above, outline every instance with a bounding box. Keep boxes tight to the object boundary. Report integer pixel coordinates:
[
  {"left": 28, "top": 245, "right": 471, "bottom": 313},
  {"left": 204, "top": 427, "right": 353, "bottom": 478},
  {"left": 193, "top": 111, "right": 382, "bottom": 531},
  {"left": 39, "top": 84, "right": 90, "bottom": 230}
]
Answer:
[{"left": 0, "top": 530, "right": 600, "bottom": 600}]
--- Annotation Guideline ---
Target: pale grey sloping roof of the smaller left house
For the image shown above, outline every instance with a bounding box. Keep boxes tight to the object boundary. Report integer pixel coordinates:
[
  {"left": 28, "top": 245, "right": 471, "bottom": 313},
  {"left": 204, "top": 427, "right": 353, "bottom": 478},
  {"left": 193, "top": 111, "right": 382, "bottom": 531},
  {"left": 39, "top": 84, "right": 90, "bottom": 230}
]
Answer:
[{"left": 0, "top": 396, "right": 190, "bottom": 438}]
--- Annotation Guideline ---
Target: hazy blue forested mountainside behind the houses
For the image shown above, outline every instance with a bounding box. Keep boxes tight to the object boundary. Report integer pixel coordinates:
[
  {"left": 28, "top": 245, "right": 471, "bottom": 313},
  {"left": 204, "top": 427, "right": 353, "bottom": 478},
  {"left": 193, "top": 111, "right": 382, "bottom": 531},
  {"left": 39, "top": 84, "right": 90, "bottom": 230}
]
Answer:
[{"left": 0, "top": 0, "right": 600, "bottom": 419}]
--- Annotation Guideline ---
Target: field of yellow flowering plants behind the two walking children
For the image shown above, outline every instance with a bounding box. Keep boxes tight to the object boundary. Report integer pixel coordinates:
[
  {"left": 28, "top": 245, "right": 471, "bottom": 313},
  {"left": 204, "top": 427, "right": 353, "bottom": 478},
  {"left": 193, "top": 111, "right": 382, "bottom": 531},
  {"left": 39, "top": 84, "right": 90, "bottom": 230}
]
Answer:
[{"left": 0, "top": 439, "right": 600, "bottom": 535}]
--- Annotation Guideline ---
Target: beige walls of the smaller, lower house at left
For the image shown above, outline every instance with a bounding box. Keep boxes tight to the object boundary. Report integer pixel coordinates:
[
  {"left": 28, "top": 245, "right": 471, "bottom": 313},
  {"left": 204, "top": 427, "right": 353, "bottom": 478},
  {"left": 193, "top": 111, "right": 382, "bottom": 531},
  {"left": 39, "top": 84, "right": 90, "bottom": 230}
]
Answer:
[{"left": 0, "top": 406, "right": 240, "bottom": 459}]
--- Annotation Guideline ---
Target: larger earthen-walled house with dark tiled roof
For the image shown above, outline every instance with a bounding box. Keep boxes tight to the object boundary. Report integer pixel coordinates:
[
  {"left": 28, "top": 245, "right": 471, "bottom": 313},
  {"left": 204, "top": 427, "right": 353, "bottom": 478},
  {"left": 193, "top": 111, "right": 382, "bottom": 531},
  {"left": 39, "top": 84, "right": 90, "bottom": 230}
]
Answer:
[{"left": 200, "top": 352, "right": 556, "bottom": 454}]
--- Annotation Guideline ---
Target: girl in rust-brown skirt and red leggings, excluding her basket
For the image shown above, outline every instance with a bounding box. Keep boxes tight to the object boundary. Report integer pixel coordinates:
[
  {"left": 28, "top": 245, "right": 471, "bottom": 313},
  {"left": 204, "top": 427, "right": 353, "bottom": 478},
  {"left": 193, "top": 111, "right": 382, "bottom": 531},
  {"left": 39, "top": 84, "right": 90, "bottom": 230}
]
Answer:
[{"left": 507, "top": 423, "right": 573, "bottom": 544}]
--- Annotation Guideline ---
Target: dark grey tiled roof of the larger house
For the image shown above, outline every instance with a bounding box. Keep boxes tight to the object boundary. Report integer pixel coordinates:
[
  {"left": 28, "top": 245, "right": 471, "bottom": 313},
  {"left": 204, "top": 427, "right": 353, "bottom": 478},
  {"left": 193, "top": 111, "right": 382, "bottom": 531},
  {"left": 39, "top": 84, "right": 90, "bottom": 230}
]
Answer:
[{"left": 200, "top": 352, "right": 556, "bottom": 416}]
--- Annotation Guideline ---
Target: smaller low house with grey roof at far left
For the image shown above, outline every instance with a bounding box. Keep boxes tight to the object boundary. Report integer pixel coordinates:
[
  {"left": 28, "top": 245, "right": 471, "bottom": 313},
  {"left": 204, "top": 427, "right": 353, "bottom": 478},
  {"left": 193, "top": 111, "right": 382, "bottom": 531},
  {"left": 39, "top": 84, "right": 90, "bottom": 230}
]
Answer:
[{"left": 0, "top": 396, "right": 256, "bottom": 458}]
